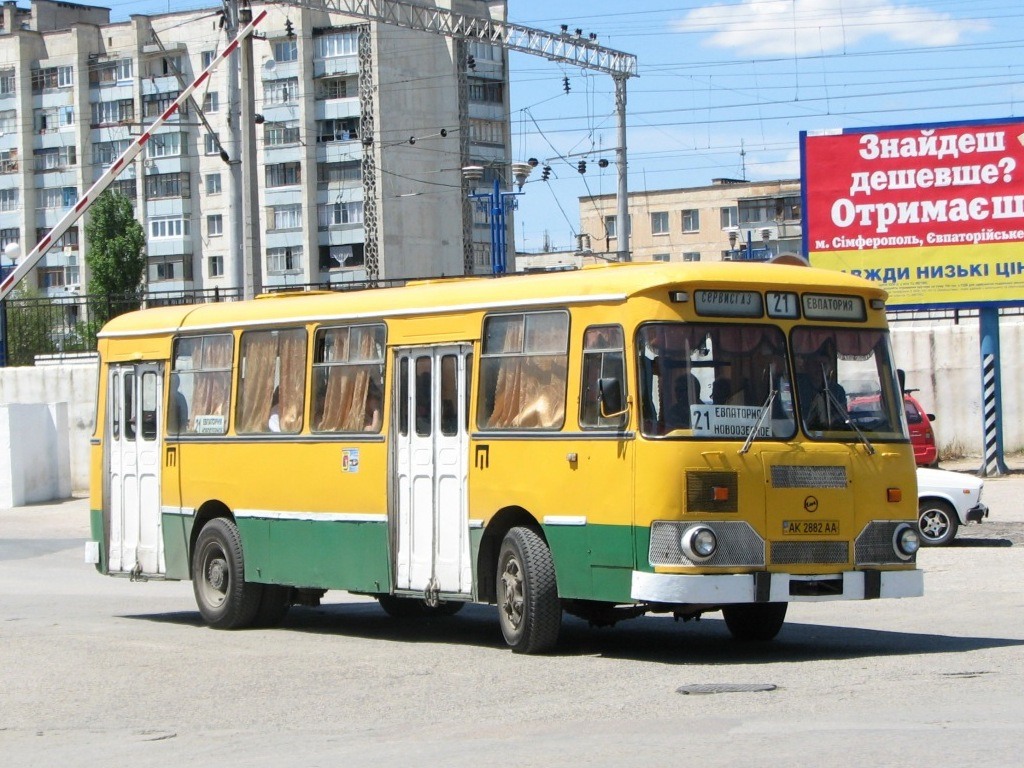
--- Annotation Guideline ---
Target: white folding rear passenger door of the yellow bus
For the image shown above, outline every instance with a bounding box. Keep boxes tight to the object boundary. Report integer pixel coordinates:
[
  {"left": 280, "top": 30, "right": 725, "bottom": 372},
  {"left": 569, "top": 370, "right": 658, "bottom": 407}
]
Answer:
[{"left": 106, "top": 365, "right": 164, "bottom": 575}]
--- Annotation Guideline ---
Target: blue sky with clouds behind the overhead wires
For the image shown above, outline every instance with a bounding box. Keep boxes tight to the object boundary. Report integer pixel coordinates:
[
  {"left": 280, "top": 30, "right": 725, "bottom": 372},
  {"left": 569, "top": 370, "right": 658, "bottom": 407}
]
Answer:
[{"left": 108, "top": 0, "right": 1024, "bottom": 250}]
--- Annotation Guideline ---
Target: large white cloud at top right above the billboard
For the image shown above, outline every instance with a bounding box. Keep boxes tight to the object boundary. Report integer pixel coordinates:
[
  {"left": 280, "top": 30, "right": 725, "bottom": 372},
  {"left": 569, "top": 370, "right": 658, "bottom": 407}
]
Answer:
[{"left": 675, "top": 0, "right": 988, "bottom": 55}]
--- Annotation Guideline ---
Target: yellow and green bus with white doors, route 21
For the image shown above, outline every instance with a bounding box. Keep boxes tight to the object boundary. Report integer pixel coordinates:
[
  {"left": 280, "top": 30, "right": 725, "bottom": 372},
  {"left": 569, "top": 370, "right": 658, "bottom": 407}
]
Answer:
[{"left": 86, "top": 263, "right": 923, "bottom": 652}]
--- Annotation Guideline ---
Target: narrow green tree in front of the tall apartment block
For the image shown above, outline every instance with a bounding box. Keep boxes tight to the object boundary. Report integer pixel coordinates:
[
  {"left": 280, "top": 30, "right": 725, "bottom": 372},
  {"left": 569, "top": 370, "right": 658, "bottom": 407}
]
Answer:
[{"left": 85, "top": 190, "right": 145, "bottom": 322}]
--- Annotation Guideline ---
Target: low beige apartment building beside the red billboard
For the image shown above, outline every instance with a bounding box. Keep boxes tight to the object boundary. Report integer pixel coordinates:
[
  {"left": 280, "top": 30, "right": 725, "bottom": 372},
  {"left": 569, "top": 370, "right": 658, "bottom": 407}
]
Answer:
[{"left": 579, "top": 179, "right": 803, "bottom": 261}]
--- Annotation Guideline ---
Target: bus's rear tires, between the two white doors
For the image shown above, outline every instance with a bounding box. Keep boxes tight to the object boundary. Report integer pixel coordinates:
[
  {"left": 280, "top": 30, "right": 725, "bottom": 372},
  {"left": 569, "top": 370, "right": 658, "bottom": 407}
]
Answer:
[{"left": 191, "top": 517, "right": 263, "bottom": 630}]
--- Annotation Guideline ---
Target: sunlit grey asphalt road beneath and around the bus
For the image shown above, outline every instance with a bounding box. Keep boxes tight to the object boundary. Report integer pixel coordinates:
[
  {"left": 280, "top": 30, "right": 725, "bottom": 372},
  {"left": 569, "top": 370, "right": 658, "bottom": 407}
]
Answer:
[{"left": 0, "top": 466, "right": 1024, "bottom": 768}]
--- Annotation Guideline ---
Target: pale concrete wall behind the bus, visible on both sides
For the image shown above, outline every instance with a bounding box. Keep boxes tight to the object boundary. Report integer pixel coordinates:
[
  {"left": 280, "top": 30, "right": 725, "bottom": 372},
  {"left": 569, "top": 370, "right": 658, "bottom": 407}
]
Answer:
[{"left": 0, "top": 318, "right": 1024, "bottom": 493}]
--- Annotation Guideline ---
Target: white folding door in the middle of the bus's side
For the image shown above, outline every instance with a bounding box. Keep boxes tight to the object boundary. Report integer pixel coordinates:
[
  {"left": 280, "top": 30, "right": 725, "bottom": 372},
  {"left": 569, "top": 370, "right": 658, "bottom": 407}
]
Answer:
[{"left": 392, "top": 345, "right": 473, "bottom": 599}]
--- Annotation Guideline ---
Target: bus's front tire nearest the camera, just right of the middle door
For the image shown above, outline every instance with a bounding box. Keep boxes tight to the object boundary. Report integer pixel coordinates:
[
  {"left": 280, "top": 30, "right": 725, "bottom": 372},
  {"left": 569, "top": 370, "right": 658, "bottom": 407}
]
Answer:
[{"left": 497, "top": 526, "right": 562, "bottom": 653}]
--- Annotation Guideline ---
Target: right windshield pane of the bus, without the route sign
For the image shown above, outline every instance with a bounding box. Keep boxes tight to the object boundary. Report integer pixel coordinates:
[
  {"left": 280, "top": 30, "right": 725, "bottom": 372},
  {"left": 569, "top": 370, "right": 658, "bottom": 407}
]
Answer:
[{"left": 792, "top": 328, "right": 907, "bottom": 440}]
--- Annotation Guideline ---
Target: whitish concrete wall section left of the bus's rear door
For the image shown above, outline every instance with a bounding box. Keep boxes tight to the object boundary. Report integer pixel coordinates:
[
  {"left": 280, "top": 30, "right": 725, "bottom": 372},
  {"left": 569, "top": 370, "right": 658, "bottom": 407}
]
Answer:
[{"left": 0, "top": 360, "right": 98, "bottom": 492}]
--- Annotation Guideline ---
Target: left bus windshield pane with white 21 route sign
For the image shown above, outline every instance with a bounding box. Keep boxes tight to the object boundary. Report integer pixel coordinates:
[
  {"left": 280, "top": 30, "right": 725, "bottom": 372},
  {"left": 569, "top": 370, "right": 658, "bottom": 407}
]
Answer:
[{"left": 637, "top": 323, "right": 797, "bottom": 440}]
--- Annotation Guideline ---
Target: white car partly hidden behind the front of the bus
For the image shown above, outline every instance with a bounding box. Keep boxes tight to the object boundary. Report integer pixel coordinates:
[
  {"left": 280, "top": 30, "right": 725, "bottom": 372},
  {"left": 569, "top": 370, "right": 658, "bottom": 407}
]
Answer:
[{"left": 918, "top": 467, "right": 988, "bottom": 547}]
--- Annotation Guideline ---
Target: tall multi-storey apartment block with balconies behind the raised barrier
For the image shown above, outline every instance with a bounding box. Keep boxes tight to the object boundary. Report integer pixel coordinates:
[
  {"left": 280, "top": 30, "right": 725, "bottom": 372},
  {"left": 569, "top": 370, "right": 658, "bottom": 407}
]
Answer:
[{"left": 0, "top": 0, "right": 511, "bottom": 296}]
